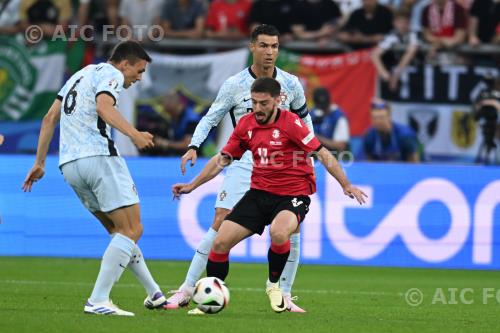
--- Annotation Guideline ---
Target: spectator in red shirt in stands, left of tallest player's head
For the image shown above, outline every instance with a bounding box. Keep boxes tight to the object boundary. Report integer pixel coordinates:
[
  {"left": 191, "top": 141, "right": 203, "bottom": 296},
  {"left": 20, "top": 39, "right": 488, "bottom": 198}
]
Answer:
[{"left": 206, "top": 0, "right": 252, "bottom": 39}]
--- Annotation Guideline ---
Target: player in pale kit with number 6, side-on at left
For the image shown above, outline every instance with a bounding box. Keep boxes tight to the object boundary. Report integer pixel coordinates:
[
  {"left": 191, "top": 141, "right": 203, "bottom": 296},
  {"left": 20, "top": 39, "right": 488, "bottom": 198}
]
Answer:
[{"left": 23, "top": 41, "right": 166, "bottom": 316}]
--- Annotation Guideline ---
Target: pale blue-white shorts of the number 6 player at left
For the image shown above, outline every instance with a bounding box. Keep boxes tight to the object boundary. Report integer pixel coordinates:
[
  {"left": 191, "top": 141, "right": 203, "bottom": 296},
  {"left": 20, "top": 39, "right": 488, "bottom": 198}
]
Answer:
[{"left": 61, "top": 156, "right": 139, "bottom": 213}]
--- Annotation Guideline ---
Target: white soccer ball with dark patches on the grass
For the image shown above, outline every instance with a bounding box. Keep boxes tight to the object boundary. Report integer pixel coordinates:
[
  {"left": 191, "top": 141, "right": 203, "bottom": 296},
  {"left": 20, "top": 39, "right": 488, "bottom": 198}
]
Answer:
[{"left": 193, "top": 277, "right": 229, "bottom": 314}]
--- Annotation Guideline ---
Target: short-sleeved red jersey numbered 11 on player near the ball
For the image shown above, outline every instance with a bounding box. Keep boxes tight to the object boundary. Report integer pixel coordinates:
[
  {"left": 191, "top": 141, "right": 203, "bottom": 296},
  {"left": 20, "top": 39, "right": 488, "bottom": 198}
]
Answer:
[{"left": 221, "top": 109, "right": 321, "bottom": 195}]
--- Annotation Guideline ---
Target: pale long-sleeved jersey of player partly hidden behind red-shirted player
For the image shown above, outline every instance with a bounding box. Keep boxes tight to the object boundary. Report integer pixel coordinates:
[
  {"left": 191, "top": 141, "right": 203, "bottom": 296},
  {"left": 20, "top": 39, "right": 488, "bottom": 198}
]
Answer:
[{"left": 190, "top": 67, "right": 312, "bottom": 163}]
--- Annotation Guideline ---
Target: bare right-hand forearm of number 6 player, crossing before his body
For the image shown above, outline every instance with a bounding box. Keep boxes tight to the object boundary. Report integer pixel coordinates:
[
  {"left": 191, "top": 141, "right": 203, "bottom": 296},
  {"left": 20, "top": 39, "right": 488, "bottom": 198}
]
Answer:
[{"left": 96, "top": 94, "right": 154, "bottom": 149}]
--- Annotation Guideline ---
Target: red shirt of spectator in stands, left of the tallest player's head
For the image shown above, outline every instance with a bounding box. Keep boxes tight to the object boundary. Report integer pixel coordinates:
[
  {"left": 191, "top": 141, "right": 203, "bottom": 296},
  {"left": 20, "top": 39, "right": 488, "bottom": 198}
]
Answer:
[{"left": 206, "top": 0, "right": 252, "bottom": 34}]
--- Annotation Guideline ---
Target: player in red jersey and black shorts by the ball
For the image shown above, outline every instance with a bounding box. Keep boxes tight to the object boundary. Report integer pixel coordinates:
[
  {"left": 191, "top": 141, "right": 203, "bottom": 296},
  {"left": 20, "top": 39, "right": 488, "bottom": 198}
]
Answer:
[{"left": 172, "top": 77, "right": 366, "bottom": 312}]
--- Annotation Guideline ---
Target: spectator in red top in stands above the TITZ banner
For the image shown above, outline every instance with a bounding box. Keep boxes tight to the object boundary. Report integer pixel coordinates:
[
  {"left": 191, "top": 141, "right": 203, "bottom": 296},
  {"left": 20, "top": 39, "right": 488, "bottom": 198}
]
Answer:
[{"left": 422, "top": 0, "right": 467, "bottom": 58}]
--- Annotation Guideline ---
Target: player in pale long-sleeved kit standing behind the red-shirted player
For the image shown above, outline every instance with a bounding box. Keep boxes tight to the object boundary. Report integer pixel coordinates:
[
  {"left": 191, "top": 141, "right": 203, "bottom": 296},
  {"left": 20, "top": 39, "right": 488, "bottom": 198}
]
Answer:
[{"left": 165, "top": 24, "right": 313, "bottom": 314}]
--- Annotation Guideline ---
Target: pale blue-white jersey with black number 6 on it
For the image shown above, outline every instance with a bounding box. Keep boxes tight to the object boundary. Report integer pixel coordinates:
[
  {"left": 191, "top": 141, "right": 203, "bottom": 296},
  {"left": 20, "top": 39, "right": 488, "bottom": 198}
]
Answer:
[{"left": 57, "top": 63, "right": 124, "bottom": 166}]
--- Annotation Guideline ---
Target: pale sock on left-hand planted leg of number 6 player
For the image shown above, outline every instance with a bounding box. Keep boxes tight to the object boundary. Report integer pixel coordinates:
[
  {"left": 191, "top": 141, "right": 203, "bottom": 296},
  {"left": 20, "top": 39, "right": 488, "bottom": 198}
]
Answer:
[{"left": 89, "top": 233, "right": 135, "bottom": 303}]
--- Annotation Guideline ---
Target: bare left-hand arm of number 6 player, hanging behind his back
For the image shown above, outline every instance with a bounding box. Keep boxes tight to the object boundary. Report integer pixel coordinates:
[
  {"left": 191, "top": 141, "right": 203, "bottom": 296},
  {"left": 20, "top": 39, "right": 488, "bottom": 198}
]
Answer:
[{"left": 22, "top": 99, "right": 61, "bottom": 192}]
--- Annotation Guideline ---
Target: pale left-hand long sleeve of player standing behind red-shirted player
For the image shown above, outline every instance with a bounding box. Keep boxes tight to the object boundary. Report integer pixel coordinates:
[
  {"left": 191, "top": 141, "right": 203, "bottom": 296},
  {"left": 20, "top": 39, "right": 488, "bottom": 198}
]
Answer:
[{"left": 189, "top": 80, "right": 234, "bottom": 147}]
